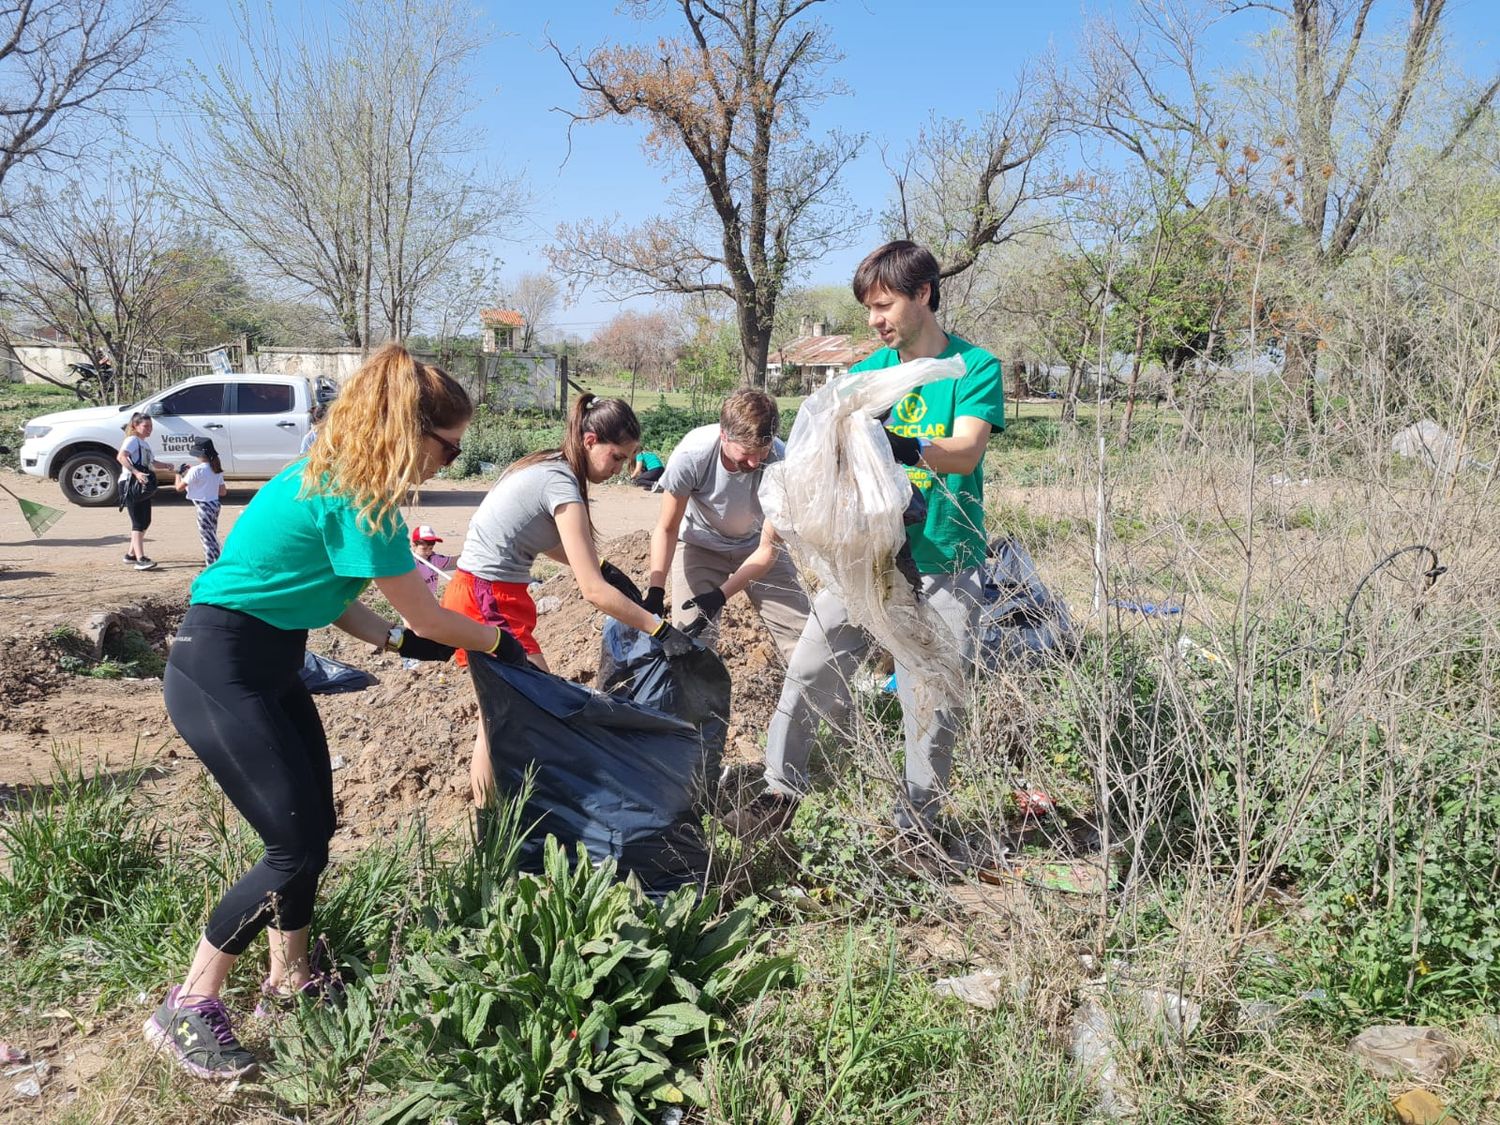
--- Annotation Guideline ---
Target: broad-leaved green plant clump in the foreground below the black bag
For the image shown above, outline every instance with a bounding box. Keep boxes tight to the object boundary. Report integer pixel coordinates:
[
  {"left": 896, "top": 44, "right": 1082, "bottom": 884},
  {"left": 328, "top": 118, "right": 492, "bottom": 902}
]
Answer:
[{"left": 272, "top": 804, "right": 792, "bottom": 1122}]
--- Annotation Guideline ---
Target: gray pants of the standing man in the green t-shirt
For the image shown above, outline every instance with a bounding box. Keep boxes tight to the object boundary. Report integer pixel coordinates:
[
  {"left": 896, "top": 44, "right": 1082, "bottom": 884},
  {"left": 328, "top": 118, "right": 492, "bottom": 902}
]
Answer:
[{"left": 765, "top": 569, "right": 984, "bottom": 824}]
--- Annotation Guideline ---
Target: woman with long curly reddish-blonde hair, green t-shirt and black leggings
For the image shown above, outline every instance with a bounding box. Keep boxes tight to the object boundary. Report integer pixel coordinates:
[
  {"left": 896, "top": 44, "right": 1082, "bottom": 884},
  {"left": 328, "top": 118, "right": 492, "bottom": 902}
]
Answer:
[{"left": 146, "top": 344, "right": 525, "bottom": 1079}]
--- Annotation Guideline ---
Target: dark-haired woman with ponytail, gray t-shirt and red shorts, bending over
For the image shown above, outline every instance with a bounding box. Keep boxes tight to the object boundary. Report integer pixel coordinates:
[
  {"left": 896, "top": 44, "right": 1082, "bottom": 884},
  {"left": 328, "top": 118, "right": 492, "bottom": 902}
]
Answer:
[{"left": 443, "top": 395, "right": 687, "bottom": 804}]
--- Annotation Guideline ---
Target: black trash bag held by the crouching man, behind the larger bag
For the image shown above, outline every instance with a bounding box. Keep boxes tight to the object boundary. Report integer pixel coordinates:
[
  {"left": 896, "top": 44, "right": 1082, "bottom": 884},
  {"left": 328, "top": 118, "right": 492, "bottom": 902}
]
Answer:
[{"left": 599, "top": 618, "right": 729, "bottom": 800}]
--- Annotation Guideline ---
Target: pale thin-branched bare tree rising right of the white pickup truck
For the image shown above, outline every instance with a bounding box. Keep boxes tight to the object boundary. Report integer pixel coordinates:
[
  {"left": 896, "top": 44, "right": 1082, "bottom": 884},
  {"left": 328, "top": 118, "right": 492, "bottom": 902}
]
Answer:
[{"left": 174, "top": 0, "right": 521, "bottom": 347}]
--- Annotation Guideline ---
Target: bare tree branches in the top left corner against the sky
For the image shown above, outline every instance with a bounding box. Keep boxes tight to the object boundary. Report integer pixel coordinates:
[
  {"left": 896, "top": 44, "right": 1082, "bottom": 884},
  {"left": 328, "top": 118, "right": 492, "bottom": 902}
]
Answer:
[{"left": 0, "top": 0, "right": 179, "bottom": 193}]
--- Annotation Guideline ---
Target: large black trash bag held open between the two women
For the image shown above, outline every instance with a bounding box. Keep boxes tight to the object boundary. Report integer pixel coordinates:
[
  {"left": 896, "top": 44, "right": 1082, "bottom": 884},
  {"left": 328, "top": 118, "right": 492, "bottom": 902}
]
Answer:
[{"left": 468, "top": 653, "right": 708, "bottom": 897}]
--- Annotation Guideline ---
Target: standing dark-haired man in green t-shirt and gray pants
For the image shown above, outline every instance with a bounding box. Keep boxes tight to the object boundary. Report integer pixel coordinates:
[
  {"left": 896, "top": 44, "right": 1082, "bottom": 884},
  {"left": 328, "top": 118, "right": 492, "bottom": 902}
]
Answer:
[{"left": 732, "top": 242, "right": 1005, "bottom": 852}]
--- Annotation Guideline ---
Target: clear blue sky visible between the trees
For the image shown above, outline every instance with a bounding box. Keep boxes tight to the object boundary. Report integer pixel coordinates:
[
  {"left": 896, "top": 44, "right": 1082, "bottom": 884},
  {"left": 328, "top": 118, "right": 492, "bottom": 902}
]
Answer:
[{"left": 158, "top": 0, "right": 1500, "bottom": 336}]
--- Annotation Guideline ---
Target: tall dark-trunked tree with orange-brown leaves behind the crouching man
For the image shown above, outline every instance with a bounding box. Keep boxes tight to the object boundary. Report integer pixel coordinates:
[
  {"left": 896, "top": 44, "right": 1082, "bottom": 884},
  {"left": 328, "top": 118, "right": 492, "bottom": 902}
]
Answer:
[{"left": 552, "top": 0, "right": 861, "bottom": 381}]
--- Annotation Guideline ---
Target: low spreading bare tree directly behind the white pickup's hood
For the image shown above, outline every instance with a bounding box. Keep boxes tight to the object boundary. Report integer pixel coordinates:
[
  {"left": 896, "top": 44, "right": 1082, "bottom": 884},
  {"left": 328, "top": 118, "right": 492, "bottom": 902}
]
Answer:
[{"left": 0, "top": 162, "right": 221, "bottom": 402}]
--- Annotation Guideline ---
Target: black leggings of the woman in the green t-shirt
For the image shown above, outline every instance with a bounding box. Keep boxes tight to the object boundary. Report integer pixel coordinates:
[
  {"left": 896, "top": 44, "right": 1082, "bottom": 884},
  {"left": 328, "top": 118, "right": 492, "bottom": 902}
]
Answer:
[{"left": 164, "top": 606, "right": 335, "bottom": 954}]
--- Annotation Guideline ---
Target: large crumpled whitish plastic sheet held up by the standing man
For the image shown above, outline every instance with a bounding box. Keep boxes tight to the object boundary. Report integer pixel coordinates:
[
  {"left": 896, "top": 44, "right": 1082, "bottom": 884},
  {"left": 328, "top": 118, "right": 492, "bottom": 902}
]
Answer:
[{"left": 761, "top": 357, "right": 965, "bottom": 716}]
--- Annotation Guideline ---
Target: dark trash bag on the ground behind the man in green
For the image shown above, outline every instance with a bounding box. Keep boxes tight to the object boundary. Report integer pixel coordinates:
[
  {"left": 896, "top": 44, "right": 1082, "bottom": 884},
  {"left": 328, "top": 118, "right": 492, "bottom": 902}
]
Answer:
[{"left": 980, "top": 536, "right": 1077, "bottom": 672}]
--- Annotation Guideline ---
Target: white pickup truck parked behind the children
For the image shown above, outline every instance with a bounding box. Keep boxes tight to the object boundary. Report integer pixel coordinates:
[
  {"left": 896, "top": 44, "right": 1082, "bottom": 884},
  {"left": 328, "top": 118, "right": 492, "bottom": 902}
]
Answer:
[{"left": 21, "top": 375, "right": 338, "bottom": 507}]
